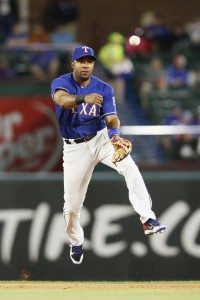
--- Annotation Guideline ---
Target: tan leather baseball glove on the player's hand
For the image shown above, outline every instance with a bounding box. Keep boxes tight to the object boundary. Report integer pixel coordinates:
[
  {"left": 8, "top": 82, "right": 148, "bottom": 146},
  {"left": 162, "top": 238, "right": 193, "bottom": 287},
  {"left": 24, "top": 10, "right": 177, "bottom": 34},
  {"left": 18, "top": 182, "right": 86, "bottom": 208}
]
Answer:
[{"left": 111, "top": 134, "right": 132, "bottom": 163}]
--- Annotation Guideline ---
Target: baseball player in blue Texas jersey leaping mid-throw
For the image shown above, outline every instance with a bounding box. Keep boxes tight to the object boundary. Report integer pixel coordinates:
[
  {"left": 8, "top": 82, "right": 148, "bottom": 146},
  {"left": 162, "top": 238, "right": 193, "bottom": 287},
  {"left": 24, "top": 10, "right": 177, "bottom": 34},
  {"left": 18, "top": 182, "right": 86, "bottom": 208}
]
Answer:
[{"left": 51, "top": 46, "right": 166, "bottom": 264}]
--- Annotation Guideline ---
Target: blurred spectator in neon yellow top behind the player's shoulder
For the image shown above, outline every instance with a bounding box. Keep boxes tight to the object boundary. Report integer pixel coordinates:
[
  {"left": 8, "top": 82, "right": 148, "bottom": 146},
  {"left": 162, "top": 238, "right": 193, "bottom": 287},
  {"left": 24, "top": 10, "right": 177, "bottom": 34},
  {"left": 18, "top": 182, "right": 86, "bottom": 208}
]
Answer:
[{"left": 98, "top": 32, "right": 134, "bottom": 101}]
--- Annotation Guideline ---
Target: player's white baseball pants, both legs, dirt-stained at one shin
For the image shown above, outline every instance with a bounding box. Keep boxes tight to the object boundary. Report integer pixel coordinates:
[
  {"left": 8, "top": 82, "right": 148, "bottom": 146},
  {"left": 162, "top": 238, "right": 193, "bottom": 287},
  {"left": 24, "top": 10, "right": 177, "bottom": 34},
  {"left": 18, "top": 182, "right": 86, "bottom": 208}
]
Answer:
[{"left": 63, "top": 128, "right": 156, "bottom": 246}]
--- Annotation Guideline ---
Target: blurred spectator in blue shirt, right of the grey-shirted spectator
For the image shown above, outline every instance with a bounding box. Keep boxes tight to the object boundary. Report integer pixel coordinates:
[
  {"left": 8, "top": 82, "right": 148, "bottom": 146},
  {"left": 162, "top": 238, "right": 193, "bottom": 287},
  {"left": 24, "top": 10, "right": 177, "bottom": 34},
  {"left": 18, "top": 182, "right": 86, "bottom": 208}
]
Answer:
[{"left": 167, "top": 54, "right": 190, "bottom": 89}]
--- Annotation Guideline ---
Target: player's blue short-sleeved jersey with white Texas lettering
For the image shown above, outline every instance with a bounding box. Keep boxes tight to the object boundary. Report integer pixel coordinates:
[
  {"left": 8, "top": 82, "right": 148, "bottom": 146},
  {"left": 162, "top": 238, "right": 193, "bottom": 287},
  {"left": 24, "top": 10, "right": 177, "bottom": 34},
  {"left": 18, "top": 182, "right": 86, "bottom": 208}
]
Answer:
[{"left": 51, "top": 73, "right": 116, "bottom": 139}]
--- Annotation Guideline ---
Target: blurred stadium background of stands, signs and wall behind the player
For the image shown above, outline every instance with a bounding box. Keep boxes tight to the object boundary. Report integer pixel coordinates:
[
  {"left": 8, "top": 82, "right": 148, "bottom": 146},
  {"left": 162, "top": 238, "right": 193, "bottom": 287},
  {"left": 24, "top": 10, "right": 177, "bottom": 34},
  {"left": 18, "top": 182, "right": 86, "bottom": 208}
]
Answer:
[{"left": 0, "top": 0, "right": 200, "bottom": 280}]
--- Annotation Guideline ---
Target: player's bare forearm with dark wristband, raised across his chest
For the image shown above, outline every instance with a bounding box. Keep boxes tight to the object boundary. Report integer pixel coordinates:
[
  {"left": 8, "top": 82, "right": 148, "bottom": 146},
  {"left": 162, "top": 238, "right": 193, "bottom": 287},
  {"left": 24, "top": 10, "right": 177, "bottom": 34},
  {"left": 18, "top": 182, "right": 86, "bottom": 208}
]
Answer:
[{"left": 54, "top": 90, "right": 103, "bottom": 109}]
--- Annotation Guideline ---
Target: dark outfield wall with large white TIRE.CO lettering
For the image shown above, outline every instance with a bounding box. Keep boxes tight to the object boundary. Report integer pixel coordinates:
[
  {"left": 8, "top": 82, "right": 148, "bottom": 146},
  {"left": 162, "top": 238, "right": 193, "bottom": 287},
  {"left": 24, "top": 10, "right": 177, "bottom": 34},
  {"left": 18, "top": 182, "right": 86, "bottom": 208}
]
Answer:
[{"left": 0, "top": 171, "right": 200, "bottom": 280}]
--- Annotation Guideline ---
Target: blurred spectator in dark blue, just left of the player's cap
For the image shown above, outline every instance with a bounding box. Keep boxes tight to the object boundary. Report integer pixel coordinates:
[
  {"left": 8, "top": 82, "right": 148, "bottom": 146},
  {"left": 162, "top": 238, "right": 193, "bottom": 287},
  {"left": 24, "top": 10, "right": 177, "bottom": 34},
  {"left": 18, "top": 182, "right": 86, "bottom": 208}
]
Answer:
[{"left": 29, "top": 44, "right": 60, "bottom": 82}]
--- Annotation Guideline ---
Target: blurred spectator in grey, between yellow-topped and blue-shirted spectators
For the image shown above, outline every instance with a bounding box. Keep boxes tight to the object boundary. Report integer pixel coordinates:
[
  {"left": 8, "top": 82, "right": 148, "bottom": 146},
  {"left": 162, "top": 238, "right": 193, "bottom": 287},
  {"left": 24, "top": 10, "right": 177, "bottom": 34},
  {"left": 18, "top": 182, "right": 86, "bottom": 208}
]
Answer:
[{"left": 139, "top": 56, "right": 167, "bottom": 111}]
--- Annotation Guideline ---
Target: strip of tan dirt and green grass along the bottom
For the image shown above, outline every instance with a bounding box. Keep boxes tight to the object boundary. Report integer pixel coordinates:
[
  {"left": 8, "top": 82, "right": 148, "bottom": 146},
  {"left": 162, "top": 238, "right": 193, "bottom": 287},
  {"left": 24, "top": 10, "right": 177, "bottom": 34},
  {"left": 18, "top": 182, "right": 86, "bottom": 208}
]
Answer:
[{"left": 0, "top": 281, "right": 200, "bottom": 300}]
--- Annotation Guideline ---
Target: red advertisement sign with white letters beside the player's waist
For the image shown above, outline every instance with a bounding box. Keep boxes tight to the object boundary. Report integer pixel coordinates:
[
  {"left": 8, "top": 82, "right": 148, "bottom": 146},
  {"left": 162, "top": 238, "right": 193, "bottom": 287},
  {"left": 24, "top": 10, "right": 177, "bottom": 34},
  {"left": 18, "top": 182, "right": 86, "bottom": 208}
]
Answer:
[{"left": 0, "top": 96, "right": 62, "bottom": 172}]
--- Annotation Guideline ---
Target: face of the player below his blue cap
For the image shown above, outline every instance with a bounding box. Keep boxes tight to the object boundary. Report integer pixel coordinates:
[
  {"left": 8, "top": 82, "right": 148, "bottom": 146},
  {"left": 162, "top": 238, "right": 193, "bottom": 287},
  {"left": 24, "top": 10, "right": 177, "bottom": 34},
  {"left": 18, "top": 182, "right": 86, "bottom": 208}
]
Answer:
[{"left": 72, "top": 56, "right": 94, "bottom": 82}]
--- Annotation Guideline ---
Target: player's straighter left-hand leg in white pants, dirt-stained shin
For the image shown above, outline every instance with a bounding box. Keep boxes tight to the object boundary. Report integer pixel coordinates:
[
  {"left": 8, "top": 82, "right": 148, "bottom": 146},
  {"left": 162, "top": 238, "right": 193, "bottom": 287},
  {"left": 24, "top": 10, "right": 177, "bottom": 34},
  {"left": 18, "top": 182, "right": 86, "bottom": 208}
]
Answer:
[{"left": 63, "top": 143, "right": 94, "bottom": 246}]
